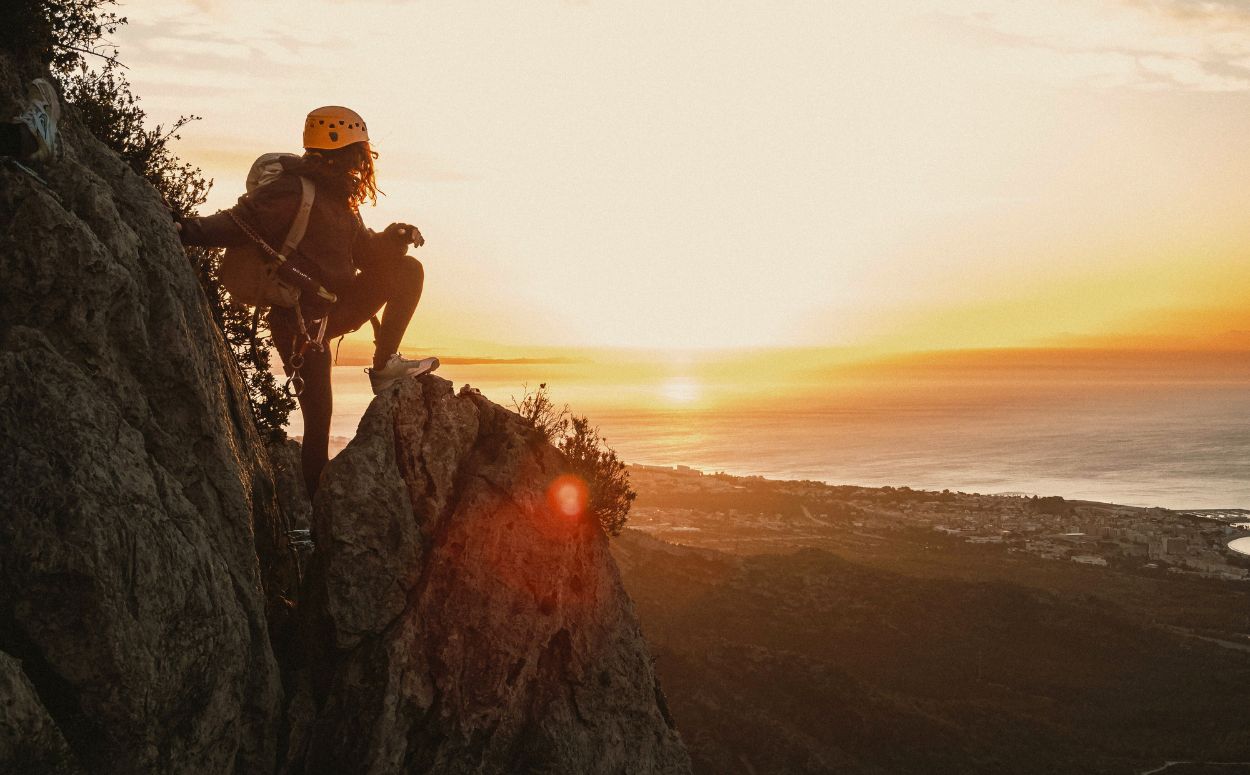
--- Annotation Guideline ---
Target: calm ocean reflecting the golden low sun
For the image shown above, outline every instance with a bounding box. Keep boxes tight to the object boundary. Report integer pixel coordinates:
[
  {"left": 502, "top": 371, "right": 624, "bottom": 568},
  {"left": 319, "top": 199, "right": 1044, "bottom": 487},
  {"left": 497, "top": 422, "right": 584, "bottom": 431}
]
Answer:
[{"left": 289, "top": 363, "right": 1250, "bottom": 509}]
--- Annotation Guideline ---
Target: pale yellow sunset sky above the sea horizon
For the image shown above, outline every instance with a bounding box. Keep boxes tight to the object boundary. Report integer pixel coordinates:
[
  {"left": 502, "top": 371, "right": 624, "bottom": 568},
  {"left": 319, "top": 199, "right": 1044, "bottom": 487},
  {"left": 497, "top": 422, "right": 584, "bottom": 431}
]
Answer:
[{"left": 114, "top": 0, "right": 1250, "bottom": 354}]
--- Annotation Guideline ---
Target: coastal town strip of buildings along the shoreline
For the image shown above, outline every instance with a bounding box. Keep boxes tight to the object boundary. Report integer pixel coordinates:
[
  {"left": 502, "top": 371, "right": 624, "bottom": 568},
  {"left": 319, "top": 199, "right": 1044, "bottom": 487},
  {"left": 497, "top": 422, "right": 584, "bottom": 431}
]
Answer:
[{"left": 630, "top": 465, "right": 1250, "bottom": 583}]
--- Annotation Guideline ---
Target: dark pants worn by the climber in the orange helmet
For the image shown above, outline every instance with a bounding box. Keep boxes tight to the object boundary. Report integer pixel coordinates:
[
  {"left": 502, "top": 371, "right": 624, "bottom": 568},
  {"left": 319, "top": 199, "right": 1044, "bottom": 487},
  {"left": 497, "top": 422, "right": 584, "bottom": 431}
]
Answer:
[{"left": 269, "top": 256, "right": 425, "bottom": 498}]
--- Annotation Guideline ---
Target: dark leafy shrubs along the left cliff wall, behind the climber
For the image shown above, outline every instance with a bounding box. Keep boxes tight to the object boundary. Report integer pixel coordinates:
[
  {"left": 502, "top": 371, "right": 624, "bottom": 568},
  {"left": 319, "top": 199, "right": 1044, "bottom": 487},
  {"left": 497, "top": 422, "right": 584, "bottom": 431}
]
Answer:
[{"left": 5, "top": 0, "right": 295, "bottom": 440}]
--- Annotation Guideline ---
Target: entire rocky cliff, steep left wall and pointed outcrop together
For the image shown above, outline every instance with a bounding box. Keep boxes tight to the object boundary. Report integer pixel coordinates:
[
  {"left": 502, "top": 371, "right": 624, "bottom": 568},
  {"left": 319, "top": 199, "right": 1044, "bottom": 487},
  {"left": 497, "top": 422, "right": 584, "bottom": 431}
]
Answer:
[{"left": 0, "top": 56, "right": 689, "bottom": 774}]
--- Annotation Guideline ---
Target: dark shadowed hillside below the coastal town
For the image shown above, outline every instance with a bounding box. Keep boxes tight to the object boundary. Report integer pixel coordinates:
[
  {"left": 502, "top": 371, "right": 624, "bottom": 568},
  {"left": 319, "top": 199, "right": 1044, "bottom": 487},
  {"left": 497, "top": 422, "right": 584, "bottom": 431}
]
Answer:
[{"left": 614, "top": 530, "right": 1250, "bottom": 774}]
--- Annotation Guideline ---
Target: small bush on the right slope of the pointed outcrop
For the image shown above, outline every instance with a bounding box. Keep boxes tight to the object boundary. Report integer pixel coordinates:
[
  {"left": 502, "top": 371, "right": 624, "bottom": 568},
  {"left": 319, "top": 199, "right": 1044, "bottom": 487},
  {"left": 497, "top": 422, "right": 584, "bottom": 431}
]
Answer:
[{"left": 513, "top": 383, "right": 638, "bottom": 536}]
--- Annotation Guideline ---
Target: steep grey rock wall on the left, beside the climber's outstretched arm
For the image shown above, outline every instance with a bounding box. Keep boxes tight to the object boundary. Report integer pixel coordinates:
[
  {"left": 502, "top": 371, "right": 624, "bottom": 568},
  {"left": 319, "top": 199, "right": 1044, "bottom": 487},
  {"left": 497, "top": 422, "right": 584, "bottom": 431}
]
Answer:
[{"left": 0, "top": 58, "right": 297, "bottom": 774}]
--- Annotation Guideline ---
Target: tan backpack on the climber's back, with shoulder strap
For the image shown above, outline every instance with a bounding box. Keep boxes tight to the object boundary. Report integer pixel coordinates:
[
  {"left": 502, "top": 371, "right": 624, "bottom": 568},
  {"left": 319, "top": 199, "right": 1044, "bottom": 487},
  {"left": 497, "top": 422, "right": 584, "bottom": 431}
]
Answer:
[{"left": 218, "top": 154, "right": 336, "bottom": 313}]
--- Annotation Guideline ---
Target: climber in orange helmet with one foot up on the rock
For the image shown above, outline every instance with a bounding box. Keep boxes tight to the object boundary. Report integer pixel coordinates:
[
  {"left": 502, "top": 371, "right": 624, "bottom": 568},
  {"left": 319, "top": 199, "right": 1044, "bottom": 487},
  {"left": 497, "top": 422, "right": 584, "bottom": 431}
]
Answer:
[{"left": 176, "top": 106, "right": 439, "bottom": 496}]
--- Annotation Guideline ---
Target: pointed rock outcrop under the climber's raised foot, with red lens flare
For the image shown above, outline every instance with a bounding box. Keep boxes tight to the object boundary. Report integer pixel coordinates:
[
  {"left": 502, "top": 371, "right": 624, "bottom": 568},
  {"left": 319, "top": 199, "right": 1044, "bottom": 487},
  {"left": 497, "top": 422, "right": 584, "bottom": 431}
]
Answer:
[{"left": 289, "top": 376, "right": 690, "bottom": 774}]
